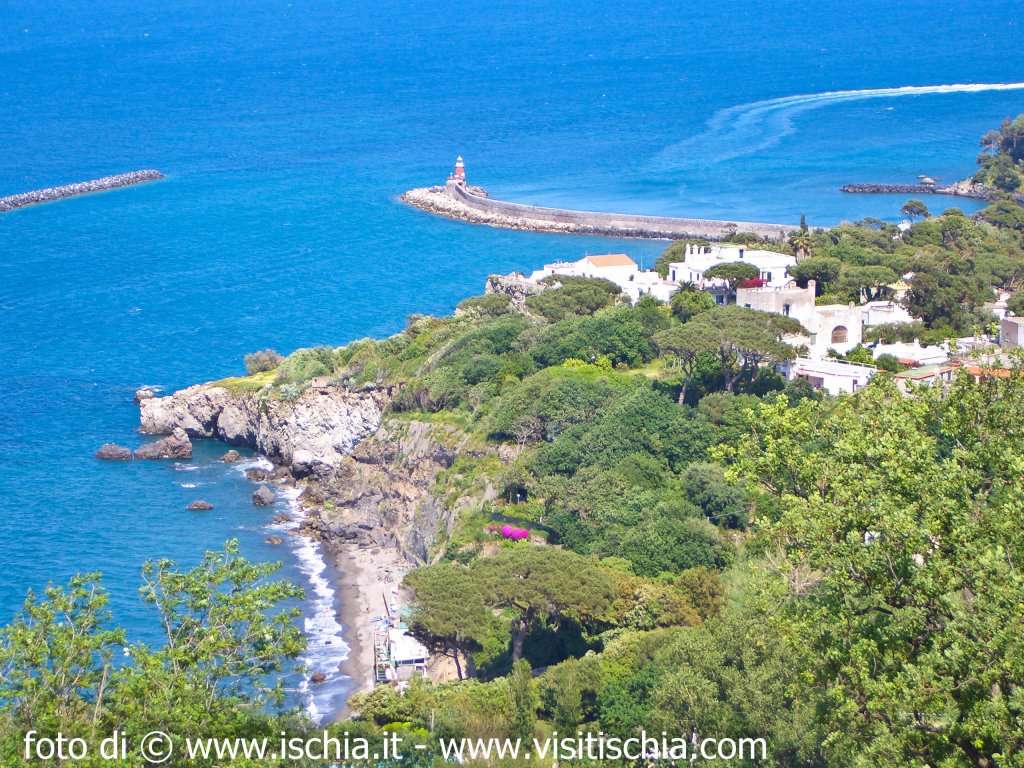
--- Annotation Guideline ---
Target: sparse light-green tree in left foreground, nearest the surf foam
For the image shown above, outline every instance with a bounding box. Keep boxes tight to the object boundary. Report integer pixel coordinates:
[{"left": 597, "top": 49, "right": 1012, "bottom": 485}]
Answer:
[{"left": 114, "top": 541, "right": 305, "bottom": 736}]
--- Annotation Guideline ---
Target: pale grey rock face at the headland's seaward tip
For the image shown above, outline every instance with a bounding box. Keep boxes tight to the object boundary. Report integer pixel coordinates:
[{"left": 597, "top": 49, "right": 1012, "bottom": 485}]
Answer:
[{"left": 139, "top": 384, "right": 388, "bottom": 477}]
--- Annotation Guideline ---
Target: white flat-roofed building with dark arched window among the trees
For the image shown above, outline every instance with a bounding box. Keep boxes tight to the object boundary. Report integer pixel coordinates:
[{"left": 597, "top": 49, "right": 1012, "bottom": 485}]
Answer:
[{"left": 736, "top": 281, "right": 864, "bottom": 357}]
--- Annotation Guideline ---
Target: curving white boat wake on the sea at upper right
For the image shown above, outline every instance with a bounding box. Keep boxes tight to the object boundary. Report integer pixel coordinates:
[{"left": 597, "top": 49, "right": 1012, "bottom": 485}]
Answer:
[{"left": 650, "top": 83, "right": 1024, "bottom": 172}]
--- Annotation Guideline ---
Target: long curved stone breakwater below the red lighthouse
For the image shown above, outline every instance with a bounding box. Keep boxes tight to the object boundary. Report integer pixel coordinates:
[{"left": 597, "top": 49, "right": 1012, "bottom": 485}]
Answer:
[{"left": 401, "top": 184, "right": 799, "bottom": 240}]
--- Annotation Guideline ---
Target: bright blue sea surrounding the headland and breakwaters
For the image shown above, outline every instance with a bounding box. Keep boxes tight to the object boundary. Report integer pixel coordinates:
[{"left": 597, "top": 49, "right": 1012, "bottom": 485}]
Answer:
[{"left": 0, "top": 0, "right": 1024, "bottom": 715}]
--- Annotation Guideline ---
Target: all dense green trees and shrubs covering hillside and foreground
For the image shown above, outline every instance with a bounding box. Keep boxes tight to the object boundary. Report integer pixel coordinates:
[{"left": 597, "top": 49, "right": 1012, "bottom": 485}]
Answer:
[{"left": 6, "top": 121, "right": 1024, "bottom": 768}]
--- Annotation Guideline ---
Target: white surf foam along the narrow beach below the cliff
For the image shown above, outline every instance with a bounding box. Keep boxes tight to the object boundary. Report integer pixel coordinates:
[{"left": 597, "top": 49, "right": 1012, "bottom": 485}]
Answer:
[{"left": 270, "top": 488, "right": 351, "bottom": 723}]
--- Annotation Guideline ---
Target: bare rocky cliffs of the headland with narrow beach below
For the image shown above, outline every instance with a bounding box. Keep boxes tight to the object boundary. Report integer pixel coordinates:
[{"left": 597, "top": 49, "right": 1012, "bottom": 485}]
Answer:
[{"left": 139, "top": 383, "right": 495, "bottom": 689}]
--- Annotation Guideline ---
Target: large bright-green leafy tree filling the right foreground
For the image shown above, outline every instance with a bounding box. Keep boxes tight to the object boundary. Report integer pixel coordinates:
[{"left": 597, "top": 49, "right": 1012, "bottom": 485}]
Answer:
[{"left": 726, "top": 370, "right": 1024, "bottom": 766}]
